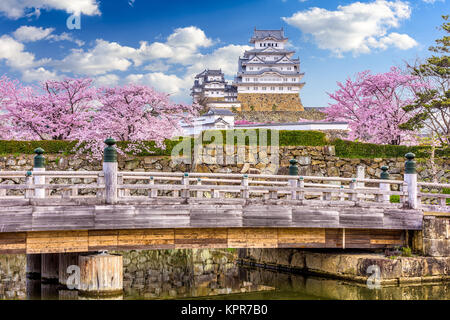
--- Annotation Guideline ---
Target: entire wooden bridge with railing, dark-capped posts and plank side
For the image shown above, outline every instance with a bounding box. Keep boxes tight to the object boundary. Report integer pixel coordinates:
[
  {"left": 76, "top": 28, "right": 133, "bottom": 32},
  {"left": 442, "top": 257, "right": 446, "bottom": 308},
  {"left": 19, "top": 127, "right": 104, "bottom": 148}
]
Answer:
[{"left": 0, "top": 141, "right": 450, "bottom": 254}]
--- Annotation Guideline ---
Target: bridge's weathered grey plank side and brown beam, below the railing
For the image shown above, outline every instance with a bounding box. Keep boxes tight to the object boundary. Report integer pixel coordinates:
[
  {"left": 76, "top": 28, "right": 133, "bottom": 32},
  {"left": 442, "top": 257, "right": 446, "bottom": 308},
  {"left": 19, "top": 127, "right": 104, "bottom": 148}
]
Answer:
[{"left": 0, "top": 198, "right": 423, "bottom": 254}]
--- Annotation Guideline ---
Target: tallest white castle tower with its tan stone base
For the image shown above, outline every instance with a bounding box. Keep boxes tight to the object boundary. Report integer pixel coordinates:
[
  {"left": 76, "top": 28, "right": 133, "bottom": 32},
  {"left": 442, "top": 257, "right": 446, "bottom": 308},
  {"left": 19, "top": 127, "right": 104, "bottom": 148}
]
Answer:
[{"left": 234, "top": 28, "right": 305, "bottom": 111}]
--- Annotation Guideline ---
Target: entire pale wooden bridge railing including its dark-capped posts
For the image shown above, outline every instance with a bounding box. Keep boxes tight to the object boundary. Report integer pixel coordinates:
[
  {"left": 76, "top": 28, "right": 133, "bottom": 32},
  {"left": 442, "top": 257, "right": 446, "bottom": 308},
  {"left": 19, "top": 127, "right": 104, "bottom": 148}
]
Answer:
[{"left": 0, "top": 139, "right": 450, "bottom": 210}]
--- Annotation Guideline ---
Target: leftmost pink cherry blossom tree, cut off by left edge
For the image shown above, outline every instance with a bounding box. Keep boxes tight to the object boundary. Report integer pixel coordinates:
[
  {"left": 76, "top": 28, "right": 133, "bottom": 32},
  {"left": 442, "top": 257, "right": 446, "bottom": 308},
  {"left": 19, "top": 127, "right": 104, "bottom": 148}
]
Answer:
[{"left": 0, "top": 77, "right": 97, "bottom": 140}]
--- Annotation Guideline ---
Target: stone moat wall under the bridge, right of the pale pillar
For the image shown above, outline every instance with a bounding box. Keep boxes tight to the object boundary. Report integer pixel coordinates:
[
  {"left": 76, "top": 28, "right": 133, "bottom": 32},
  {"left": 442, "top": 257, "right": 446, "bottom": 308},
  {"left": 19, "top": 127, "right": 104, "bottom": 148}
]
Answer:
[{"left": 118, "top": 249, "right": 268, "bottom": 299}]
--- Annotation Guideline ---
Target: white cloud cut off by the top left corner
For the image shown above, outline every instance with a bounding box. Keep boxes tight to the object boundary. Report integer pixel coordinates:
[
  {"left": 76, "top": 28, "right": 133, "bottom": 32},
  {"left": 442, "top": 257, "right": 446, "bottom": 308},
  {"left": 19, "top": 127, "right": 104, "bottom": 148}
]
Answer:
[{"left": 0, "top": 0, "right": 100, "bottom": 19}]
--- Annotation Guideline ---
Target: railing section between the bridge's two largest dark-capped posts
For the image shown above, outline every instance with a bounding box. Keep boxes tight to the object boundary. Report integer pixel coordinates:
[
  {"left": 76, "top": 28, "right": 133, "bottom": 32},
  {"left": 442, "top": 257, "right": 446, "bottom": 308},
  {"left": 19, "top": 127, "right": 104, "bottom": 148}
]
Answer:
[{"left": 117, "top": 172, "right": 407, "bottom": 204}]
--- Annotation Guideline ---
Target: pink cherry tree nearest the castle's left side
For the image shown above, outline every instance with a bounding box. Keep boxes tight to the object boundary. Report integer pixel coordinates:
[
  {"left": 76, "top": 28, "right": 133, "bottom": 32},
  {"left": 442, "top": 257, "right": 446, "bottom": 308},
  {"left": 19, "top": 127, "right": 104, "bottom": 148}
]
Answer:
[{"left": 77, "top": 85, "right": 201, "bottom": 156}]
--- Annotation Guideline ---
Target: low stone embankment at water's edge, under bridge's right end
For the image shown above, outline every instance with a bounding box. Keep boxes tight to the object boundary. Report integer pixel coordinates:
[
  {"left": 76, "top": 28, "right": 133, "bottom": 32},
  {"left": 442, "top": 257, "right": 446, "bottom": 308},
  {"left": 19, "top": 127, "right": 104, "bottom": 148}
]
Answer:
[{"left": 239, "top": 249, "right": 450, "bottom": 285}]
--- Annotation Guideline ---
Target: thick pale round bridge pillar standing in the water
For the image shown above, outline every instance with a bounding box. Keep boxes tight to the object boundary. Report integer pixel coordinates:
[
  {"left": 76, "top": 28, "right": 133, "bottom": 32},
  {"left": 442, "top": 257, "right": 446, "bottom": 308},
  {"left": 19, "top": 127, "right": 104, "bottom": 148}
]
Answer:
[{"left": 78, "top": 253, "right": 123, "bottom": 297}]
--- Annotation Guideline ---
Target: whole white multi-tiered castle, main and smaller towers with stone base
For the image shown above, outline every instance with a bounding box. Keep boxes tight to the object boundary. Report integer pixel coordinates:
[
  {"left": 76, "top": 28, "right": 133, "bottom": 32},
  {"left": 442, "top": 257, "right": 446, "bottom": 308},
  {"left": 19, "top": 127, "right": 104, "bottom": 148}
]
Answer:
[{"left": 191, "top": 29, "right": 305, "bottom": 111}]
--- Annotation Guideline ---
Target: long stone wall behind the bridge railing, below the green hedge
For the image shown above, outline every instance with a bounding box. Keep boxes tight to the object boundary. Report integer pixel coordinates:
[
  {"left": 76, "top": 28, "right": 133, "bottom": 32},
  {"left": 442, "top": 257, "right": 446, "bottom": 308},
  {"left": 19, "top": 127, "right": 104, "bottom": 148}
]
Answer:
[{"left": 0, "top": 145, "right": 450, "bottom": 183}]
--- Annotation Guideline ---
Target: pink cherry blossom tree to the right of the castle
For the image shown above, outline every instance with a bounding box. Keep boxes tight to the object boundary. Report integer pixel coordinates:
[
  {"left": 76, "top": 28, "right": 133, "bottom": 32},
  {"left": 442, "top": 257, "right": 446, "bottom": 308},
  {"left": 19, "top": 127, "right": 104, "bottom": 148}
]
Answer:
[{"left": 325, "top": 67, "right": 427, "bottom": 145}]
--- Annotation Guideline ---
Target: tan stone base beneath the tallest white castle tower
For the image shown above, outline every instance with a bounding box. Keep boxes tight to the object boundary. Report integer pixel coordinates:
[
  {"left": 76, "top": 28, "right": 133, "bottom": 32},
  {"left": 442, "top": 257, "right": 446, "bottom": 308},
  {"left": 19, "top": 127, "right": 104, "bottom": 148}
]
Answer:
[{"left": 237, "top": 93, "right": 304, "bottom": 111}]
